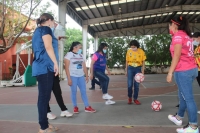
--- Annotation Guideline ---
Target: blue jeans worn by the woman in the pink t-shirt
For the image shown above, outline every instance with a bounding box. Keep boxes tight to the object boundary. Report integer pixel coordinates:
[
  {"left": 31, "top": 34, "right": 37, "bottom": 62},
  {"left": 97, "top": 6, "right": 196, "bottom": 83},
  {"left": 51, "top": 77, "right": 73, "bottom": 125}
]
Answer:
[{"left": 174, "top": 68, "right": 198, "bottom": 125}]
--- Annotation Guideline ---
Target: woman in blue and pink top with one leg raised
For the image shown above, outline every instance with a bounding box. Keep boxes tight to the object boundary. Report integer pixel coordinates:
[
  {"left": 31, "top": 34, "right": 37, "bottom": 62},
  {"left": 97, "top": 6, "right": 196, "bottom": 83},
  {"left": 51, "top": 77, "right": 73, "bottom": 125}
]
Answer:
[{"left": 90, "top": 43, "right": 115, "bottom": 105}]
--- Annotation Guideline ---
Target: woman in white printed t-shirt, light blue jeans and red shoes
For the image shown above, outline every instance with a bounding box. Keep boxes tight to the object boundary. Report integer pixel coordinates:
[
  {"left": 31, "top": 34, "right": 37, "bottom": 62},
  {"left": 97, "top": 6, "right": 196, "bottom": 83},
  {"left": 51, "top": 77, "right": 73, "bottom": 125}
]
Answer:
[{"left": 64, "top": 42, "right": 96, "bottom": 113}]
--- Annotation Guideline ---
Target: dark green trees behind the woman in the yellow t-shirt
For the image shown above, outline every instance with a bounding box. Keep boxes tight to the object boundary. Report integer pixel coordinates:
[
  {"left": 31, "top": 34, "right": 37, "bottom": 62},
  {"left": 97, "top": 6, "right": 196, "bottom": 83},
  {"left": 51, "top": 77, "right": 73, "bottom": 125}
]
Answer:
[{"left": 99, "top": 34, "right": 171, "bottom": 68}]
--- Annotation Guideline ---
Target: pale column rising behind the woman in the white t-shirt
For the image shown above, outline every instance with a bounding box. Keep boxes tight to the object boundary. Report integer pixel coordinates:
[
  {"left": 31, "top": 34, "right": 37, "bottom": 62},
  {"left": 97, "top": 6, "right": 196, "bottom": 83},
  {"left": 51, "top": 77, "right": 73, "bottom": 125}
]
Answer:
[{"left": 82, "top": 25, "right": 88, "bottom": 60}]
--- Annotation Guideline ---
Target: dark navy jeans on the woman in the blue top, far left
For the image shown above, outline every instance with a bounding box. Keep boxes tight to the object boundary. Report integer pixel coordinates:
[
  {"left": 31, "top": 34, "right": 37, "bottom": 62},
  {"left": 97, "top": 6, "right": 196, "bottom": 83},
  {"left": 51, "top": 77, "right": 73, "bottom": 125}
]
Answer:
[{"left": 37, "top": 72, "right": 54, "bottom": 130}]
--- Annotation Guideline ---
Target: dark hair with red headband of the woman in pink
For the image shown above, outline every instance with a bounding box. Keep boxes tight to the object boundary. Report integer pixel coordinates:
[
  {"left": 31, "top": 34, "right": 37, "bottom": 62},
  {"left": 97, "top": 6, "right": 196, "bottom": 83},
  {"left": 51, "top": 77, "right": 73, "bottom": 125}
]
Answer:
[{"left": 170, "top": 16, "right": 191, "bottom": 37}]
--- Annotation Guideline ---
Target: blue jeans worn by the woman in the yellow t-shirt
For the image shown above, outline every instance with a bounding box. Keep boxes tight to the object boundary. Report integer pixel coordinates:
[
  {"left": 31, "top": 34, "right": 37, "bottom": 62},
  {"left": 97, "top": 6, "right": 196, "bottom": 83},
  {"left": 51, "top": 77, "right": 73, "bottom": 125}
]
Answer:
[{"left": 127, "top": 66, "right": 142, "bottom": 100}]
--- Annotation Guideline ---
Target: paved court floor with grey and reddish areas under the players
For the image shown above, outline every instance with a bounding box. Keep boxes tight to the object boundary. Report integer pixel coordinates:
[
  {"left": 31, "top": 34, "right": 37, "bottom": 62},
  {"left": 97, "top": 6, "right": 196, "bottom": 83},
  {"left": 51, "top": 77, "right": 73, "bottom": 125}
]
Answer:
[{"left": 0, "top": 74, "right": 200, "bottom": 133}]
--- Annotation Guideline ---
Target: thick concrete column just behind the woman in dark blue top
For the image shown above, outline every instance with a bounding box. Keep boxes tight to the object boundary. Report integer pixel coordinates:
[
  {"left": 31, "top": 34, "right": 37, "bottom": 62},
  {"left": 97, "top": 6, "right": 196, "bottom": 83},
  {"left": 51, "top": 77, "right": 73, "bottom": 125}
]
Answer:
[{"left": 58, "top": 1, "right": 67, "bottom": 79}]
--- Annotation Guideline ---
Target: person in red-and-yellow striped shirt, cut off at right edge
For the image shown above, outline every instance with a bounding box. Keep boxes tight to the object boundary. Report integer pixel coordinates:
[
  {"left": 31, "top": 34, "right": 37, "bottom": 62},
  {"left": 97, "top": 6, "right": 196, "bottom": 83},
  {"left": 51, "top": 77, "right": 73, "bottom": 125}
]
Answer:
[{"left": 192, "top": 32, "right": 200, "bottom": 114}]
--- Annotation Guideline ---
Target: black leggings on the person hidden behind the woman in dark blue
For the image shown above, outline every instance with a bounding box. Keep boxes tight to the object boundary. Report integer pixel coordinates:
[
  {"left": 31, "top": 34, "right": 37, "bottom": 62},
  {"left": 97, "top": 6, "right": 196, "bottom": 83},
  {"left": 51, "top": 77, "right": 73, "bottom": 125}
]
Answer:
[{"left": 47, "top": 76, "right": 67, "bottom": 113}]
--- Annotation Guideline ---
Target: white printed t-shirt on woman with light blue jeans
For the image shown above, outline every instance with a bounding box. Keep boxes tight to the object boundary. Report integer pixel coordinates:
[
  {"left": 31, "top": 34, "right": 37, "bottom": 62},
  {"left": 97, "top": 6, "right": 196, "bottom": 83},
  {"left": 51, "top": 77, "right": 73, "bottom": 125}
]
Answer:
[{"left": 65, "top": 52, "right": 84, "bottom": 77}]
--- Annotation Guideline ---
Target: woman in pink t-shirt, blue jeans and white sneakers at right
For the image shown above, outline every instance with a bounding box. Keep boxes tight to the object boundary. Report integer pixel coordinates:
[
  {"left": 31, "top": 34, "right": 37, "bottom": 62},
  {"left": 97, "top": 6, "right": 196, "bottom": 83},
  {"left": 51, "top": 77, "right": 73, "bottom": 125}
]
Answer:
[{"left": 167, "top": 16, "right": 199, "bottom": 133}]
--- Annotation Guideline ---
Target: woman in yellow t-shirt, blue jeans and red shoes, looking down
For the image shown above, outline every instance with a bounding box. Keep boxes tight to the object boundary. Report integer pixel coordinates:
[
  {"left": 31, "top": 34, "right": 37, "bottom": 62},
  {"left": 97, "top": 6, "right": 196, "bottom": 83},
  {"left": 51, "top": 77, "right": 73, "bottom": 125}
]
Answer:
[{"left": 125, "top": 40, "right": 146, "bottom": 105}]
